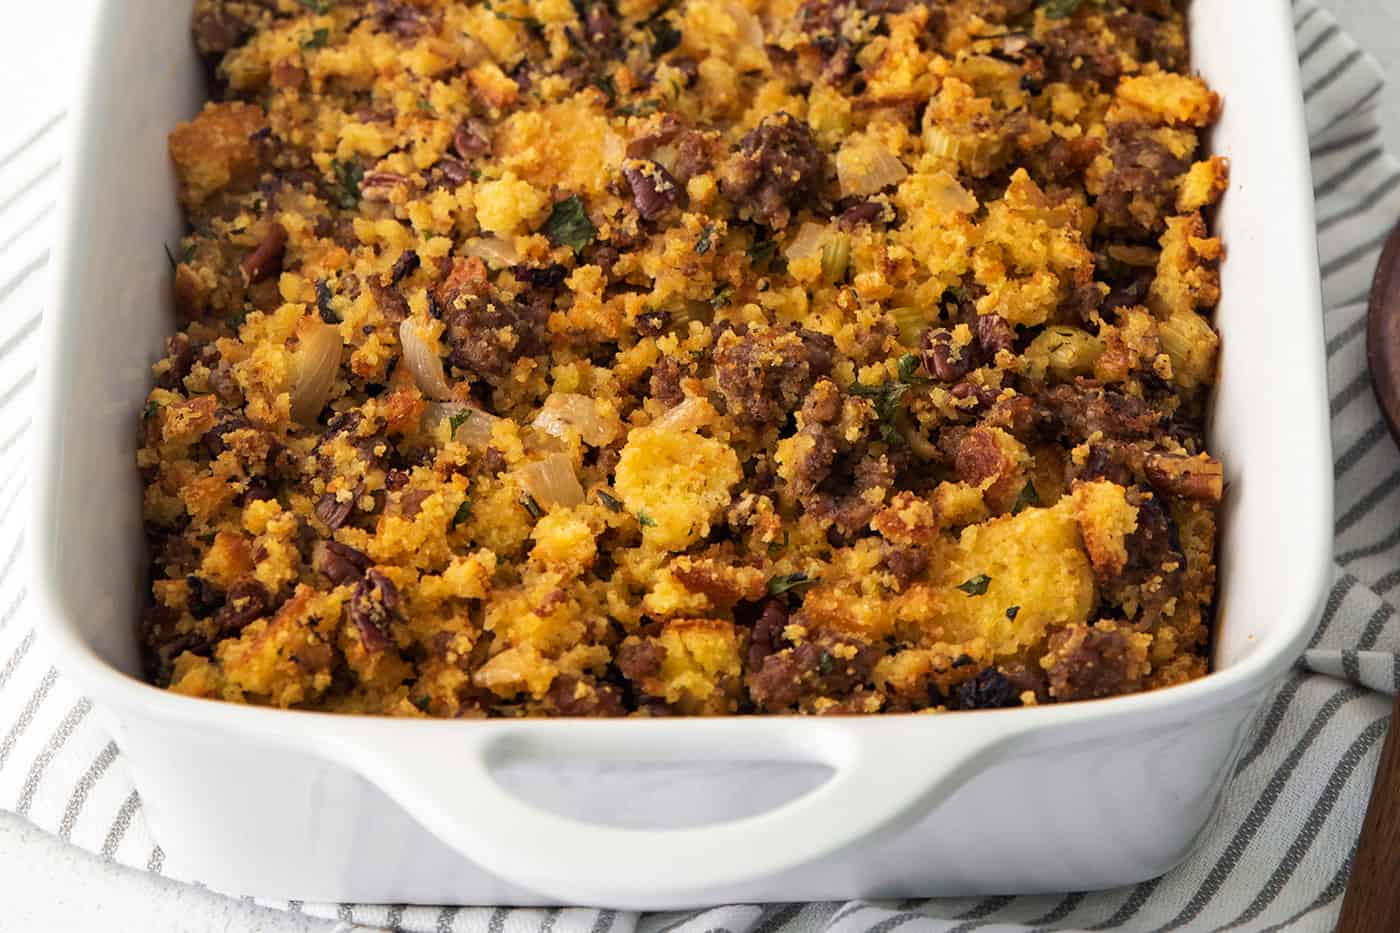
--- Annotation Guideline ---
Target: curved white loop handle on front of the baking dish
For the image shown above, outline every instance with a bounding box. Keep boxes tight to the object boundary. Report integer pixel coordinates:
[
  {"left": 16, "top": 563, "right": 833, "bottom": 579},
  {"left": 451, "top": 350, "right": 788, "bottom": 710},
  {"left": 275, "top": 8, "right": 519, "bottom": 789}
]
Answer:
[{"left": 330, "top": 713, "right": 1022, "bottom": 909}]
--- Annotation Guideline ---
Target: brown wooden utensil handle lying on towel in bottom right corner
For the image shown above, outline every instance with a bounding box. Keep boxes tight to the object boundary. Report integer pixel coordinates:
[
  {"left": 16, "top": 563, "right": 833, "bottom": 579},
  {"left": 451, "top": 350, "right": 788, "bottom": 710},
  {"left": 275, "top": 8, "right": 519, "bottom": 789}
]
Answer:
[{"left": 1337, "top": 686, "right": 1400, "bottom": 933}]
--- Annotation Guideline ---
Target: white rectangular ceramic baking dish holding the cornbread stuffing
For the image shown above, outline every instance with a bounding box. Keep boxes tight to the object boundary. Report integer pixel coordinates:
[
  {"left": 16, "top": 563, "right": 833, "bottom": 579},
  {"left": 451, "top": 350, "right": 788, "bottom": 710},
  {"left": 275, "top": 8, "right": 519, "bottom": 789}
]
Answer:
[{"left": 32, "top": 0, "right": 1331, "bottom": 908}]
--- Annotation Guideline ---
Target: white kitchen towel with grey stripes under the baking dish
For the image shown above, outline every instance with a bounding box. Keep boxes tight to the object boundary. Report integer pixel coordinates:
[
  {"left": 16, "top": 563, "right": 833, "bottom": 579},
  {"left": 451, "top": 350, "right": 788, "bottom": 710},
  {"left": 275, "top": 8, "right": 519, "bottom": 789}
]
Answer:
[{"left": 0, "top": 0, "right": 1400, "bottom": 933}]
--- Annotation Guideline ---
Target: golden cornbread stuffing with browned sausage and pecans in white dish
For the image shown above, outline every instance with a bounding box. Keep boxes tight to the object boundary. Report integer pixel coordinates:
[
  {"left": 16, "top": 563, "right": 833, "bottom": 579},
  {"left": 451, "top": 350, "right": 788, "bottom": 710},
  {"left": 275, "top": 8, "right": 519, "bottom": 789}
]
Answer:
[{"left": 139, "top": 0, "right": 1226, "bottom": 717}]
